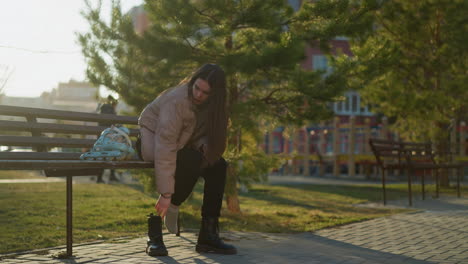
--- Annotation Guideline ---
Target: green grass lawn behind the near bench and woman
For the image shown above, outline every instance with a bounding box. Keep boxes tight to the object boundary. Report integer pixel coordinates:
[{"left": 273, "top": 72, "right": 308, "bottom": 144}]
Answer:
[{"left": 0, "top": 170, "right": 462, "bottom": 253}]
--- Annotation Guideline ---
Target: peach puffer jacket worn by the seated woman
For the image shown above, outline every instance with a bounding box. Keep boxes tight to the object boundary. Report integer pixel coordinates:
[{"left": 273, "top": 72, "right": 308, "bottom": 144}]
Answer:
[{"left": 138, "top": 84, "right": 197, "bottom": 193}]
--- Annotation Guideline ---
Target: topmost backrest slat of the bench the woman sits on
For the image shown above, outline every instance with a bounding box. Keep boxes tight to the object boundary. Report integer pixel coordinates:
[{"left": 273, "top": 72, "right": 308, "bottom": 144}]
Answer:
[{"left": 0, "top": 105, "right": 138, "bottom": 125}]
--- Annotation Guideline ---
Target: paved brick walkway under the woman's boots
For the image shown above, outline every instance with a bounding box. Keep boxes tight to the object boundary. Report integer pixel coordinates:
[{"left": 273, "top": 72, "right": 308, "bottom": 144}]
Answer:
[{"left": 0, "top": 175, "right": 468, "bottom": 264}]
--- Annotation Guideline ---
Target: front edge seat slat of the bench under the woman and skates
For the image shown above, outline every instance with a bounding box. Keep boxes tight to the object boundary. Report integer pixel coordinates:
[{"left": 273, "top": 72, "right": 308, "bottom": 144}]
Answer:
[{"left": 0, "top": 160, "right": 154, "bottom": 170}]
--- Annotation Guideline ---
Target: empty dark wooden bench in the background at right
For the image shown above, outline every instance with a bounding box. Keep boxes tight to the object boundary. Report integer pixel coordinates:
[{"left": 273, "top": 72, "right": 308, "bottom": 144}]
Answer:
[{"left": 369, "top": 138, "right": 463, "bottom": 206}]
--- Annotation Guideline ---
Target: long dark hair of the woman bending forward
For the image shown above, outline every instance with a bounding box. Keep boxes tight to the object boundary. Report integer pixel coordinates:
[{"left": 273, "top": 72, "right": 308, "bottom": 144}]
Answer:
[{"left": 188, "top": 64, "right": 228, "bottom": 164}]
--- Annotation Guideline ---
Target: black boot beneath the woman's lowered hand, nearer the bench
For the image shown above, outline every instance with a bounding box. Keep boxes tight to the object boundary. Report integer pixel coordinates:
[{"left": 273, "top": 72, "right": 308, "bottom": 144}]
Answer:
[{"left": 146, "top": 214, "right": 167, "bottom": 256}]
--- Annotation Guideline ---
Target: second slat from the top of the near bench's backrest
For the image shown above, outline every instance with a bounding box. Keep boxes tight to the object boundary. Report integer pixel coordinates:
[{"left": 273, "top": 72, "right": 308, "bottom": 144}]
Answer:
[{"left": 0, "top": 120, "right": 139, "bottom": 136}]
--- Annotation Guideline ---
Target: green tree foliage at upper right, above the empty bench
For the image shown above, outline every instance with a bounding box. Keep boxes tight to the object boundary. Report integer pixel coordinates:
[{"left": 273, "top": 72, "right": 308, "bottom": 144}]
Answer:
[{"left": 307, "top": 0, "right": 468, "bottom": 142}]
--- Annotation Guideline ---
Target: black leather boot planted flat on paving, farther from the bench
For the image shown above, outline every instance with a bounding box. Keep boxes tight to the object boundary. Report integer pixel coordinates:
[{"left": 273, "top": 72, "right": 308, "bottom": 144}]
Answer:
[{"left": 195, "top": 217, "right": 237, "bottom": 255}]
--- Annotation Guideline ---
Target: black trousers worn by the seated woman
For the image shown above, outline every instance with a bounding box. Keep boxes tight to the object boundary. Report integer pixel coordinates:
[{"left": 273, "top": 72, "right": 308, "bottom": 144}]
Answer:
[{"left": 171, "top": 148, "right": 227, "bottom": 217}]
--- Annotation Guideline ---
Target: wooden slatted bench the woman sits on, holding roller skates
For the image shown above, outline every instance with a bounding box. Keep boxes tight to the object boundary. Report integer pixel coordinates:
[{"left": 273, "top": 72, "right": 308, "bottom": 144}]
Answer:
[{"left": 0, "top": 105, "right": 153, "bottom": 256}]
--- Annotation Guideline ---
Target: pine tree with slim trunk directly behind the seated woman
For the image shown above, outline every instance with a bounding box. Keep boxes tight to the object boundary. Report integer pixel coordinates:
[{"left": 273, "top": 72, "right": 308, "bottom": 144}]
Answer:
[{"left": 79, "top": 0, "right": 342, "bottom": 211}]
